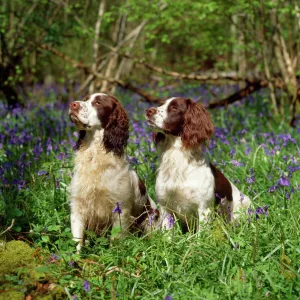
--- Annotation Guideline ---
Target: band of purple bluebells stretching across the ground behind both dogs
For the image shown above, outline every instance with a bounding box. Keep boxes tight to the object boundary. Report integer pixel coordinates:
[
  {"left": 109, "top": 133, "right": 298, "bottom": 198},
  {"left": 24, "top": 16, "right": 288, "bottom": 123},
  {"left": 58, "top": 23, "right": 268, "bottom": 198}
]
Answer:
[{"left": 0, "top": 85, "right": 300, "bottom": 227}]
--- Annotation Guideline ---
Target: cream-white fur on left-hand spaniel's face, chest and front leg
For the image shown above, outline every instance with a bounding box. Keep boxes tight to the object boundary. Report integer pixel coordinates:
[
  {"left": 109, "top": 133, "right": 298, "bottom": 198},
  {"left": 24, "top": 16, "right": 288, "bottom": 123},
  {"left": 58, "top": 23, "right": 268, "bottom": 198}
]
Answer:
[{"left": 70, "top": 94, "right": 156, "bottom": 250}]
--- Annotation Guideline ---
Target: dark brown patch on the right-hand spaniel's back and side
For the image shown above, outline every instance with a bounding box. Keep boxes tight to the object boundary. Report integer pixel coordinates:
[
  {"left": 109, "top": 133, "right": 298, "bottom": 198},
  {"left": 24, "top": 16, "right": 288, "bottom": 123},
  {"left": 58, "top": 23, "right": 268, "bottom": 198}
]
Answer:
[{"left": 209, "top": 163, "right": 233, "bottom": 204}]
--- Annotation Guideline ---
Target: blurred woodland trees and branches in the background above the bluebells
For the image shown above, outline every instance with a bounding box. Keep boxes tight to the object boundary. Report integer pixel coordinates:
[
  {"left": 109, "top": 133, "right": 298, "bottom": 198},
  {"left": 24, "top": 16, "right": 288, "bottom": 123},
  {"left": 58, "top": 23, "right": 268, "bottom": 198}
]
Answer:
[{"left": 0, "top": 0, "right": 300, "bottom": 124}]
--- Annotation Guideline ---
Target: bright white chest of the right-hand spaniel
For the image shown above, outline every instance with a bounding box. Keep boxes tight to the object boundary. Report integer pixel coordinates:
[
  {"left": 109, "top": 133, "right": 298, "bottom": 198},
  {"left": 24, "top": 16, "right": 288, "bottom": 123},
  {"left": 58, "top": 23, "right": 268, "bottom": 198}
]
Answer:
[{"left": 156, "top": 149, "right": 215, "bottom": 218}]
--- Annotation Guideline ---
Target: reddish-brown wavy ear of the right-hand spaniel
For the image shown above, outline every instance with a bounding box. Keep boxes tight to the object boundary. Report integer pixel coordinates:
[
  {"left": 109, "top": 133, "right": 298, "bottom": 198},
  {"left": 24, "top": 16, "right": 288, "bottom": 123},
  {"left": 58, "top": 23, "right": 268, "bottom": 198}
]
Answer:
[{"left": 181, "top": 99, "right": 214, "bottom": 149}]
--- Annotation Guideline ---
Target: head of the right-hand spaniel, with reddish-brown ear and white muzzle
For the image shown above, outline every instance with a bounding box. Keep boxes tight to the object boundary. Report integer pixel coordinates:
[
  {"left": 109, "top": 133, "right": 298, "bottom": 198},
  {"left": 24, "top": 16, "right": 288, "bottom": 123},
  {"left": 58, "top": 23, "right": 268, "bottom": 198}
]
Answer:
[{"left": 146, "top": 97, "right": 214, "bottom": 149}]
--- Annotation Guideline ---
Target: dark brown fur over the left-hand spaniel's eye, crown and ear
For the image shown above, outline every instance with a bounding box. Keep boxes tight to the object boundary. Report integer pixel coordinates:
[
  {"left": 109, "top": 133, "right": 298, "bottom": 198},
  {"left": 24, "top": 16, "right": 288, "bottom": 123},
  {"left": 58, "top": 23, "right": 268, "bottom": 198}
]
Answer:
[{"left": 92, "top": 95, "right": 129, "bottom": 156}]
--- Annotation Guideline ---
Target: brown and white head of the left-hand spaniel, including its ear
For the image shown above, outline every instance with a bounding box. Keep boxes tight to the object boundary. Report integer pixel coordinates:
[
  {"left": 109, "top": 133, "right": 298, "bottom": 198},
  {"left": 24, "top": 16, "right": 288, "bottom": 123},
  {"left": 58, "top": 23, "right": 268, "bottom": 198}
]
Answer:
[{"left": 69, "top": 93, "right": 129, "bottom": 156}]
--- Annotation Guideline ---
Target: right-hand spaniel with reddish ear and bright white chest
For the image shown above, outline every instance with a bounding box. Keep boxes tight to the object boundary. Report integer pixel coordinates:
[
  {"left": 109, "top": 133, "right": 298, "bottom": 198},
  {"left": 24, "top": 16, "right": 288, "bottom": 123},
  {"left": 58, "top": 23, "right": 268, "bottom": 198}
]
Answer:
[{"left": 146, "top": 98, "right": 250, "bottom": 229}]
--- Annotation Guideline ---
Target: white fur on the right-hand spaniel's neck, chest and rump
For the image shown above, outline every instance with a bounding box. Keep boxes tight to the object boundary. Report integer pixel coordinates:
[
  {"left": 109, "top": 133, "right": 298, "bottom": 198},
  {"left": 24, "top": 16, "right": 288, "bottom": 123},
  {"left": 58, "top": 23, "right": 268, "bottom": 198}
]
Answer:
[{"left": 155, "top": 135, "right": 250, "bottom": 229}]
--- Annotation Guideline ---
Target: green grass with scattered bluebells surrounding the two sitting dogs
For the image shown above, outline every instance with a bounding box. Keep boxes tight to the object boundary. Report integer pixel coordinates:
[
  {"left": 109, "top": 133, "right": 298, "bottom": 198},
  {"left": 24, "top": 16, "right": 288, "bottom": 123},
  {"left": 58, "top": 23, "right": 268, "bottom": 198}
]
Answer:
[{"left": 0, "top": 85, "right": 300, "bottom": 299}]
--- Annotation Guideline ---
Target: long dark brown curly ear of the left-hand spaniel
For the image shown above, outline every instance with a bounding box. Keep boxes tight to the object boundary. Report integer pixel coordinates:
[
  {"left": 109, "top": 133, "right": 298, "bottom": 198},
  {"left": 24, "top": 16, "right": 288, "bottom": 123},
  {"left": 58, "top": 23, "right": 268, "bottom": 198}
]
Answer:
[{"left": 103, "top": 101, "right": 129, "bottom": 156}]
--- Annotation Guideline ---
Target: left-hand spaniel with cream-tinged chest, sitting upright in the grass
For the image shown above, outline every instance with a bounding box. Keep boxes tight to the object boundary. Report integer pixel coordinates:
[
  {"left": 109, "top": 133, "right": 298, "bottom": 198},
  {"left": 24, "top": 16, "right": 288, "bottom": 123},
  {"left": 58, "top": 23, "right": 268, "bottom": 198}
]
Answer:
[{"left": 69, "top": 93, "right": 158, "bottom": 251}]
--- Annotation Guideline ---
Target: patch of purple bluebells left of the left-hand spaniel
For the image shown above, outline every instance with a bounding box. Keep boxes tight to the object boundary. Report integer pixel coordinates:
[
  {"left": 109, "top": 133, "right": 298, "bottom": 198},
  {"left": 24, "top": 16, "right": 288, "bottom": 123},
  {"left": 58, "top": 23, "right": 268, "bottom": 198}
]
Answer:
[{"left": 0, "top": 101, "right": 74, "bottom": 191}]
